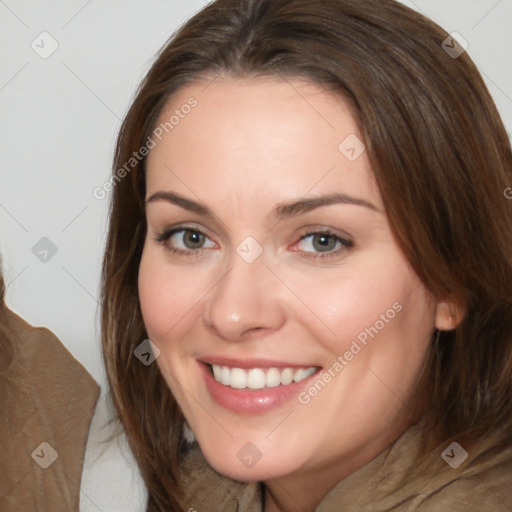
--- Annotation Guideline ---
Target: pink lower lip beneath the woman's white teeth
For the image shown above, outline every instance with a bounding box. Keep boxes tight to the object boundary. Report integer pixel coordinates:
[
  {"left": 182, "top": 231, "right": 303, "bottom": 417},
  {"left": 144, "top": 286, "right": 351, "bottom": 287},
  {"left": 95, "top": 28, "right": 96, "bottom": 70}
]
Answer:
[{"left": 198, "top": 362, "right": 319, "bottom": 414}]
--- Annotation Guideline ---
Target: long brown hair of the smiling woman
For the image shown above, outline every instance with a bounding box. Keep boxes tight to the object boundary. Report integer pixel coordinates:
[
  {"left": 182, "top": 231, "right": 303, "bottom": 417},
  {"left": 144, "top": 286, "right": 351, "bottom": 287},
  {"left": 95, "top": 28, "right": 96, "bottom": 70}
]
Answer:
[{"left": 102, "top": 0, "right": 512, "bottom": 510}]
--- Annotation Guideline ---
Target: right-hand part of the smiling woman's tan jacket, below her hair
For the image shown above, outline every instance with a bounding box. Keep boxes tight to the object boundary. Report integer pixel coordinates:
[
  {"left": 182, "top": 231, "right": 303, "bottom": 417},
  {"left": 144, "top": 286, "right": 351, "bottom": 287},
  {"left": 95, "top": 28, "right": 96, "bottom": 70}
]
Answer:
[{"left": 317, "top": 425, "right": 512, "bottom": 512}]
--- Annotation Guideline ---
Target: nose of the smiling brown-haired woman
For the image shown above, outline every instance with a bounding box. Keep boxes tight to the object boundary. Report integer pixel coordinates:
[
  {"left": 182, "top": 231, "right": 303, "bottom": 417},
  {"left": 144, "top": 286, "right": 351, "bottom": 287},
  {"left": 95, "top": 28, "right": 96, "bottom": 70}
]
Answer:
[{"left": 202, "top": 254, "right": 285, "bottom": 341}]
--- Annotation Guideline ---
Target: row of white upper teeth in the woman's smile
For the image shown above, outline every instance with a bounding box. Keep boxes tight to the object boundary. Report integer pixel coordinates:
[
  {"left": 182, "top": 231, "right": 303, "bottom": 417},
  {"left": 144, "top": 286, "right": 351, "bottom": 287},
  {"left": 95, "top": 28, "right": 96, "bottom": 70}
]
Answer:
[{"left": 212, "top": 364, "right": 316, "bottom": 389}]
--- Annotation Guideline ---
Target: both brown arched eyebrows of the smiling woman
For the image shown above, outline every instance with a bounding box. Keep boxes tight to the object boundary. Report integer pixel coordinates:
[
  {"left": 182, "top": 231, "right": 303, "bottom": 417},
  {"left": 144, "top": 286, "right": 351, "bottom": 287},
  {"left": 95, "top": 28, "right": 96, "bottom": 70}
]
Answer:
[{"left": 146, "top": 191, "right": 379, "bottom": 220}]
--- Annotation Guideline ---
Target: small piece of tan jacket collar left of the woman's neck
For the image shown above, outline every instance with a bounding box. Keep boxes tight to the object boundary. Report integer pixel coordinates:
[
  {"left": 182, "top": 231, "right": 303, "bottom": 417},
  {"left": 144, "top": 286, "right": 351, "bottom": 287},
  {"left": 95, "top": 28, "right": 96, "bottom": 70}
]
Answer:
[{"left": 183, "top": 443, "right": 261, "bottom": 512}]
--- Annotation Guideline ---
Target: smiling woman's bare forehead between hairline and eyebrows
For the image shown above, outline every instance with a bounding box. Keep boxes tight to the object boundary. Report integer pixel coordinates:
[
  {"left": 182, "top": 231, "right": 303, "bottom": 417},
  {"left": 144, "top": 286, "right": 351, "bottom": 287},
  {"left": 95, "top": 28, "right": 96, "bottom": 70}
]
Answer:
[{"left": 143, "top": 73, "right": 380, "bottom": 206}]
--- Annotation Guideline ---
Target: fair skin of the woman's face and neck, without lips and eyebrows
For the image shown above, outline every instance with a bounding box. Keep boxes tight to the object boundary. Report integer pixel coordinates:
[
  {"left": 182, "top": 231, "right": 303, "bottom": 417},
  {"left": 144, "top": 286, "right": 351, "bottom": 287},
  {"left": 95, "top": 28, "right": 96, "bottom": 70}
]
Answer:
[{"left": 139, "top": 77, "right": 455, "bottom": 512}]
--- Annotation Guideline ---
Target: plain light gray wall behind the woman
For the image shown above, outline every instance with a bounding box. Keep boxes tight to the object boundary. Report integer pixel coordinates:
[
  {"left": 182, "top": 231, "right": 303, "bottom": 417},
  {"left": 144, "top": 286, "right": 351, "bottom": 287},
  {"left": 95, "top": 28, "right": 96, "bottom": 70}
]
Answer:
[{"left": 0, "top": 0, "right": 512, "bottom": 387}]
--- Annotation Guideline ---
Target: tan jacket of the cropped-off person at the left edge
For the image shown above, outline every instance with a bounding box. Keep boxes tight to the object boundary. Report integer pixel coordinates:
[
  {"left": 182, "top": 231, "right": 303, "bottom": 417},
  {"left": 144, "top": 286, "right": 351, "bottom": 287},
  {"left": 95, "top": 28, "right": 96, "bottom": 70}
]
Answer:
[{"left": 0, "top": 310, "right": 99, "bottom": 512}]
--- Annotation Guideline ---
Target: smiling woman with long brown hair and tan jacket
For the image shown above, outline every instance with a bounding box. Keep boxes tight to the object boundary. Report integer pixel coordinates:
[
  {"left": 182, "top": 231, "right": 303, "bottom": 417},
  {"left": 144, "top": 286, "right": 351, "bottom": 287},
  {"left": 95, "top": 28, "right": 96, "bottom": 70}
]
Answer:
[{"left": 102, "top": 0, "right": 512, "bottom": 512}]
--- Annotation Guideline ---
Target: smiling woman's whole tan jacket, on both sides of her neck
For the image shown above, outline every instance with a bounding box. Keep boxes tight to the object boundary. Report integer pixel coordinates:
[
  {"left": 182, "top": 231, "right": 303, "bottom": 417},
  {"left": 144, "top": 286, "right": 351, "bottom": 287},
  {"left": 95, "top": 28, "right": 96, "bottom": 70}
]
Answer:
[{"left": 185, "top": 426, "right": 512, "bottom": 512}]
